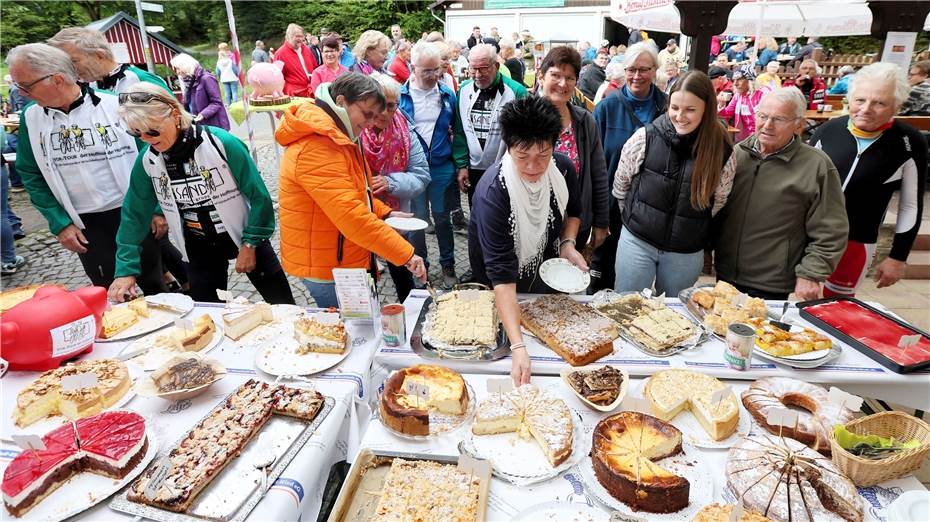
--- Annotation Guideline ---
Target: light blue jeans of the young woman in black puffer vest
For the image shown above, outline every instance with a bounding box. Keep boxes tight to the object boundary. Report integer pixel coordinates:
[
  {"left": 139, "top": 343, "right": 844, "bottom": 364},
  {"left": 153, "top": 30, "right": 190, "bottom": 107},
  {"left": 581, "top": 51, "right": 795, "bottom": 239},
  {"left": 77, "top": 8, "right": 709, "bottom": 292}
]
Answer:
[{"left": 614, "top": 227, "right": 704, "bottom": 297}]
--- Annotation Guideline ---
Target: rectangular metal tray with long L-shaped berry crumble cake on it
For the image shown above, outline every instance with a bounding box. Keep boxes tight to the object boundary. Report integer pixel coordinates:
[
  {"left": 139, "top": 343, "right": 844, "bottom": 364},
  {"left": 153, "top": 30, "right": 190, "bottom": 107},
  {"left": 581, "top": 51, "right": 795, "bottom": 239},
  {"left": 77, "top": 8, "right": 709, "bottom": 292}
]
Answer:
[{"left": 109, "top": 380, "right": 335, "bottom": 522}]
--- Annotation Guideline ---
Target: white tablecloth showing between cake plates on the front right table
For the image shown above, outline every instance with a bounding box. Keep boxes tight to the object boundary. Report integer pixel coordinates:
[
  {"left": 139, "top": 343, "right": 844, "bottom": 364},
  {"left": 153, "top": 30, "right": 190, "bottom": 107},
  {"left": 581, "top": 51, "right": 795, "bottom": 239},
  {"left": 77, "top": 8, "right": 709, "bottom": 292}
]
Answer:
[{"left": 362, "top": 375, "right": 924, "bottom": 520}]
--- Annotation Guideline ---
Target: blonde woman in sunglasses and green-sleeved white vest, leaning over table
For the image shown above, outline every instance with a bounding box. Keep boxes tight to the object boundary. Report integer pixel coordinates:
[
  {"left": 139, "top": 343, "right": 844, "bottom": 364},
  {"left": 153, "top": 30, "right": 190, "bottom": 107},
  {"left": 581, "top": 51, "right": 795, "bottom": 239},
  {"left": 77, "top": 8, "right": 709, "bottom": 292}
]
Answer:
[{"left": 110, "top": 83, "right": 294, "bottom": 304}]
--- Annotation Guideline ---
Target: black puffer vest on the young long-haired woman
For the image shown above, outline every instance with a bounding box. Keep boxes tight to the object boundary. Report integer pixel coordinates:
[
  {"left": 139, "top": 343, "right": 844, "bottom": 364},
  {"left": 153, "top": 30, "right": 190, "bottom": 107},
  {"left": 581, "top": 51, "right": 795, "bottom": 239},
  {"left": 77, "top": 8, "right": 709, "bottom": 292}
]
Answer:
[{"left": 623, "top": 114, "right": 731, "bottom": 254}]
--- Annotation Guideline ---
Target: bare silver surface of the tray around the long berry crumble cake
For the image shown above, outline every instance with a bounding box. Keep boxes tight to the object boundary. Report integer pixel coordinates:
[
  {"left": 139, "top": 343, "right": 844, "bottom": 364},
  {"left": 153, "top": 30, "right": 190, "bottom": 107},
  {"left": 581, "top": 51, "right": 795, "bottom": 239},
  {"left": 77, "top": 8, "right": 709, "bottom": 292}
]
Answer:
[{"left": 109, "top": 390, "right": 335, "bottom": 522}]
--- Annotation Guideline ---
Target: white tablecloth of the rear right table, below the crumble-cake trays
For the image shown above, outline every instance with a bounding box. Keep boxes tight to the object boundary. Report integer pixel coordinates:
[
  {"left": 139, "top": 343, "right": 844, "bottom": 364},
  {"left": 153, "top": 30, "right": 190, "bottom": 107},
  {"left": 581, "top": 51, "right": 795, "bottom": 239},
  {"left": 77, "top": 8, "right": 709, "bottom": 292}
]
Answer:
[{"left": 372, "top": 290, "right": 930, "bottom": 411}]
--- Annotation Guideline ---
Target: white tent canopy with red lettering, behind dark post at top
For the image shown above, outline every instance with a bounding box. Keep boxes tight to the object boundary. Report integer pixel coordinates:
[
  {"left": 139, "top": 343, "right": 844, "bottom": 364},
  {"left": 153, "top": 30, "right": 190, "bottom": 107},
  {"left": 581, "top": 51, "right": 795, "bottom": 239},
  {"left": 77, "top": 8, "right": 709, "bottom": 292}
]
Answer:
[{"left": 611, "top": 0, "right": 872, "bottom": 36}]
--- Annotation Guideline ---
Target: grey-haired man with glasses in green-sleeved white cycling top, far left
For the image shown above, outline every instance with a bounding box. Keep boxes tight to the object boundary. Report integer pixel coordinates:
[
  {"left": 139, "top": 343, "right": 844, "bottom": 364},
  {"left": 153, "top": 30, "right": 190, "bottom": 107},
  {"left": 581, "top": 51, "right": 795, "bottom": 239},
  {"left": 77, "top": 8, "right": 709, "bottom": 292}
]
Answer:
[{"left": 7, "top": 43, "right": 167, "bottom": 294}]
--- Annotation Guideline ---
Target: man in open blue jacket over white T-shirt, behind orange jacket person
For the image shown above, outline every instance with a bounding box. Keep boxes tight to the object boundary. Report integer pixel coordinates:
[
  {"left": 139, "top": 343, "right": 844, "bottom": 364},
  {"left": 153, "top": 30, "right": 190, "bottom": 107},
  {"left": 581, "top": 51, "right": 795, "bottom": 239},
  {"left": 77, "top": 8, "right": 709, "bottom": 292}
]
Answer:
[{"left": 400, "top": 41, "right": 459, "bottom": 288}]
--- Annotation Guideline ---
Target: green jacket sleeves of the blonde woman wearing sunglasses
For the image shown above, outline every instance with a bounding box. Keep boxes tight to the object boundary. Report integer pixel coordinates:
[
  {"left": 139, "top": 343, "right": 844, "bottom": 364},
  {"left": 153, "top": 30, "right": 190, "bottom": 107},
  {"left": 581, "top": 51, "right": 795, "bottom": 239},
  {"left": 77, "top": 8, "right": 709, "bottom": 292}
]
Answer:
[{"left": 116, "top": 127, "right": 275, "bottom": 277}]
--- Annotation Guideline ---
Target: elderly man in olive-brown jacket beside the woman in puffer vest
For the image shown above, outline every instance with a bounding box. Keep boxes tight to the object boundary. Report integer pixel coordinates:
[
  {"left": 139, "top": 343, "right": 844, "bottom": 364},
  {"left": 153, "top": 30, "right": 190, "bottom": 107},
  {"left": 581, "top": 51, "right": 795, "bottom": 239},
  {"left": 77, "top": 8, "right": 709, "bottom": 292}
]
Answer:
[{"left": 714, "top": 87, "right": 849, "bottom": 300}]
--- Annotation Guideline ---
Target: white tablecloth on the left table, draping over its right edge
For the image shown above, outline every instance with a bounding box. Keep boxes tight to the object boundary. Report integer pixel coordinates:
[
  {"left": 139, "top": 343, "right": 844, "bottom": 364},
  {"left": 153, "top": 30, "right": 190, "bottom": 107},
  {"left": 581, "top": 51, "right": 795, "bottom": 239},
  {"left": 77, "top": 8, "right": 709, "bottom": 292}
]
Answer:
[{"left": 0, "top": 303, "right": 380, "bottom": 520}]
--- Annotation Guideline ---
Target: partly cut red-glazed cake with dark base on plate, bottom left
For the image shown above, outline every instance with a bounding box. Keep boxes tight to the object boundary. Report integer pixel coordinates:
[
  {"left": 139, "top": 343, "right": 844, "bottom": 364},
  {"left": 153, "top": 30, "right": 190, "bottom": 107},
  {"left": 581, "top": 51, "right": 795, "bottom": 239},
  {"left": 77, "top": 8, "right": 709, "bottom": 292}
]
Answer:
[{"left": 0, "top": 410, "right": 158, "bottom": 521}]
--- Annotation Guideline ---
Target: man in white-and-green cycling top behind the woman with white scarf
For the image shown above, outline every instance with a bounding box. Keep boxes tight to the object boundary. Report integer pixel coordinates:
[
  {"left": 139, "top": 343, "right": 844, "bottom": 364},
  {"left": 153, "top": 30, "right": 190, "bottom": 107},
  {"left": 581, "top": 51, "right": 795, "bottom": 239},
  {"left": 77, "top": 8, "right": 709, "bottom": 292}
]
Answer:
[{"left": 452, "top": 44, "right": 526, "bottom": 204}]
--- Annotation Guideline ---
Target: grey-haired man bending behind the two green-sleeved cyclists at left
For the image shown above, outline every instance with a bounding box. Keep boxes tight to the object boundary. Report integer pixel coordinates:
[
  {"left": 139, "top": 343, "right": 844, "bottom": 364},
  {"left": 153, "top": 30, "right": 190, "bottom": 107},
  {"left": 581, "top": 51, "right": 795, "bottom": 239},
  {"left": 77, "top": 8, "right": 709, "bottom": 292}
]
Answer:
[{"left": 46, "top": 27, "right": 171, "bottom": 93}]
